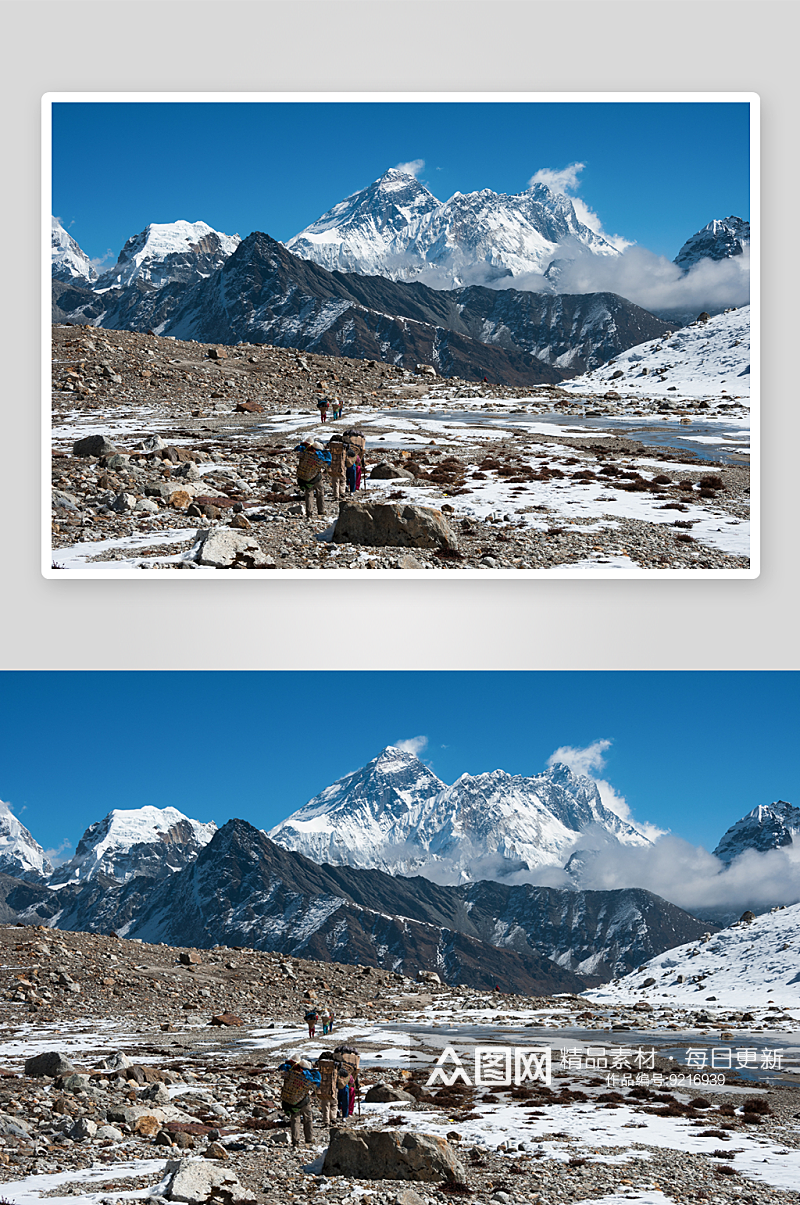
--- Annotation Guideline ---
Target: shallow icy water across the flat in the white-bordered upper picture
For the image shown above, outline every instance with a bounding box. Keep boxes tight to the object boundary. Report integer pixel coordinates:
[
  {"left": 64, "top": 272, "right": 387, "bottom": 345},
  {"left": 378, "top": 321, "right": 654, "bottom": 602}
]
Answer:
[{"left": 384, "top": 410, "right": 749, "bottom": 464}]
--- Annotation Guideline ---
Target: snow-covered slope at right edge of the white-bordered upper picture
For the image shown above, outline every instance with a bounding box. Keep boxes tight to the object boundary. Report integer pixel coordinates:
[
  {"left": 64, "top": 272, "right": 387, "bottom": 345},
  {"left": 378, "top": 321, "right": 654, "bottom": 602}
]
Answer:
[{"left": 561, "top": 305, "right": 751, "bottom": 405}]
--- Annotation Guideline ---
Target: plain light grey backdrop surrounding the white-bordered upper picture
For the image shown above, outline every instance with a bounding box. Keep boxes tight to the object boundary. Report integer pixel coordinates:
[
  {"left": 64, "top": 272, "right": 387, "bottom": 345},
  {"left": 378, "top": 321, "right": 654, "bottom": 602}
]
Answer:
[{"left": 0, "top": 0, "right": 799, "bottom": 674}]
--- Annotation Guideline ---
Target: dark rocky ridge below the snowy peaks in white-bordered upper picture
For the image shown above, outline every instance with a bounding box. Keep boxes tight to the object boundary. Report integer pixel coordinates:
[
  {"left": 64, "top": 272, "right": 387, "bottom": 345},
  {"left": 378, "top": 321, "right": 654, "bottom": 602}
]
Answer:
[{"left": 53, "top": 231, "right": 669, "bottom": 386}]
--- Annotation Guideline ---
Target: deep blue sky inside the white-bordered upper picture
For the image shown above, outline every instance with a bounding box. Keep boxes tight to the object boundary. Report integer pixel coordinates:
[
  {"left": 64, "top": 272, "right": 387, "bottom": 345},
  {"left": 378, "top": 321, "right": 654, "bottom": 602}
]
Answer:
[{"left": 53, "top": 101, "right": 749, "bottom": 266}]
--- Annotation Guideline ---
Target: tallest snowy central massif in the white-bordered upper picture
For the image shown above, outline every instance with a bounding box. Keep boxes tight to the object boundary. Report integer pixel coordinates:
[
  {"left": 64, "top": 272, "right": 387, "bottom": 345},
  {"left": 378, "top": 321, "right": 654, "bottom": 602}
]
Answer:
[{"left": 287, "top": 167, "right": 618, "bottom": 288}]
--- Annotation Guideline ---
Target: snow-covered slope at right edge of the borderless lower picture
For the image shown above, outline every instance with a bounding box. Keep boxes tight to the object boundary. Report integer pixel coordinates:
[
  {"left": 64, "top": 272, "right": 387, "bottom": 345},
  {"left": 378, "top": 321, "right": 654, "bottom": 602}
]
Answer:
[{"left": 587, "top": 904, "right": 800, "bottom": 1009}]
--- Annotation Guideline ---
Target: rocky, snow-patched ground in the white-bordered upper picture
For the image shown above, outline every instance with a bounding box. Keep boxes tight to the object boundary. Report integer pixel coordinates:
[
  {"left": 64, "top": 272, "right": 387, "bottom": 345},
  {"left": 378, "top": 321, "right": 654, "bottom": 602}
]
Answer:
[{"left": 52, "top": 325, "right": 749, "bottom": 575}]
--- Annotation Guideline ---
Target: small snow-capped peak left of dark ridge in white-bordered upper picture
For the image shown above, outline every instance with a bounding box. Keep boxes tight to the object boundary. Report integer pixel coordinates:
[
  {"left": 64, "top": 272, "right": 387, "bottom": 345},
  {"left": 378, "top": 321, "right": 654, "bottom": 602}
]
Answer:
[{"left": 95, "top": 221, "right": 241, "bottom": 290}]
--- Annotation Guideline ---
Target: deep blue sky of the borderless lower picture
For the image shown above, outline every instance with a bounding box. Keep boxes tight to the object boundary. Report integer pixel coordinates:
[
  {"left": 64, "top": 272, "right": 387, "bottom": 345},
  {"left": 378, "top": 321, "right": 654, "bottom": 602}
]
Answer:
[{"left": 0, "top": 671, "right": 800, "bottom": 867}]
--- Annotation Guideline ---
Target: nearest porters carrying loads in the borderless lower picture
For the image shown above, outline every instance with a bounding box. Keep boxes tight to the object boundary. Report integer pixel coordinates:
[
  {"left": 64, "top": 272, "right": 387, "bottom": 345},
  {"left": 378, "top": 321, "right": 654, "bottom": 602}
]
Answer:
[{"left": 278, "top": 1046, "right": 360, "bottom": 1146}]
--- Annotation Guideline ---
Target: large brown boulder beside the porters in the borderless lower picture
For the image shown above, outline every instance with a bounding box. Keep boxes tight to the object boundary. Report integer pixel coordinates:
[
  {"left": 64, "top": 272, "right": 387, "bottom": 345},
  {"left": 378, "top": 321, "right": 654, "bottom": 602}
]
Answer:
[{"left": 322, "top": 1128, "right": 465, "bottom": 1182}]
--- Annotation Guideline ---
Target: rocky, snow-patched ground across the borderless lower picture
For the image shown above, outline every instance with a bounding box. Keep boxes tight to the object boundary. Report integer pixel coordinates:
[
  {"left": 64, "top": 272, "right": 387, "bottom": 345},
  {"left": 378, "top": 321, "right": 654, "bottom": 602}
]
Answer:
[{"left": 0, "top": 927, "right": 800, "bottom": 1205}]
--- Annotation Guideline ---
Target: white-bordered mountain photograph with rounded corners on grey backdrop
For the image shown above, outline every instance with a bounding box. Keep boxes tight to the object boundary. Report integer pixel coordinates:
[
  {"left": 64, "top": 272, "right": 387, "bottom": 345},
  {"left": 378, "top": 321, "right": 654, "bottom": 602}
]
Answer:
[{"left": 42, "top": 93, "right": 759, "bottom": 580}]
